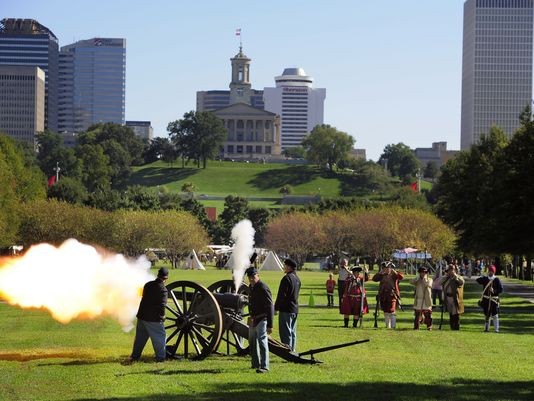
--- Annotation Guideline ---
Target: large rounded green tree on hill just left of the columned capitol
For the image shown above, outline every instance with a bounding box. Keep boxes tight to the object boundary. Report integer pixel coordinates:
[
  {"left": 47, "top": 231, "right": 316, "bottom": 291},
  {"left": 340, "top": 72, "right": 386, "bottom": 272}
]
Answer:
[{"left": 167, "top": 111, "right": 227, "bottom": 168}]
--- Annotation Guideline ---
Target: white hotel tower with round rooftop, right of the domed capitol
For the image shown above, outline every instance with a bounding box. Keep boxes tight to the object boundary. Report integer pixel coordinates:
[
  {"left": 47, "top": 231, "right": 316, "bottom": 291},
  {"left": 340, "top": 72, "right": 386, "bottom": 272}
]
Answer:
[{"left": 263, "top": 68, "right": 326, "bottom": 149}]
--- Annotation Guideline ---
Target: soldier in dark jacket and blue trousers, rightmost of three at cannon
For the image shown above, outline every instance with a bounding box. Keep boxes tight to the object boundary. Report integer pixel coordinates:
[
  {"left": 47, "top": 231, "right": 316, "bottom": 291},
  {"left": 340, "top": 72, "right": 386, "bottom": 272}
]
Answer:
[{"left": 274, "top": 259, "right": 300, "bottom": 351}]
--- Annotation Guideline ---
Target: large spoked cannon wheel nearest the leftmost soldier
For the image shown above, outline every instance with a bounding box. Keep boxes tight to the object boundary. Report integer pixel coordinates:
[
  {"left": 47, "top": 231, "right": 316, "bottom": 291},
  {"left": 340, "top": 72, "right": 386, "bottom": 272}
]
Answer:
[{"left": 165, "top": 281, "right": 223, "bottom": 359}]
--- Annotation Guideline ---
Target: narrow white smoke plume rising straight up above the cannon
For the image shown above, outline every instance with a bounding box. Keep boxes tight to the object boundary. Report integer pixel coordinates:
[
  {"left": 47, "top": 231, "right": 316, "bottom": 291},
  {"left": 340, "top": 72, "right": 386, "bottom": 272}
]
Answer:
[{"left": 231, "top": 219, "right": 256, "bottom": 291}]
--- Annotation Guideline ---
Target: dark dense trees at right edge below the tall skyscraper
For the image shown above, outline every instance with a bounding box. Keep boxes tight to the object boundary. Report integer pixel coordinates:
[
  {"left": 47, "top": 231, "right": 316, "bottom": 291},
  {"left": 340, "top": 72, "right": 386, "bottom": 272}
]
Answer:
[{"left": 432, "top": 107, "right": 534, "bottom": 279}]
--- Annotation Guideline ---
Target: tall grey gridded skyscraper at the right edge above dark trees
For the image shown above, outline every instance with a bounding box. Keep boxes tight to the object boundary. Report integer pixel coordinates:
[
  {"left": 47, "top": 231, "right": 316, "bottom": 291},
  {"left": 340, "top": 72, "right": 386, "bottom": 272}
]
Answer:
[{"left": 461, "top": 0, "right": 533, "bottom": 150}]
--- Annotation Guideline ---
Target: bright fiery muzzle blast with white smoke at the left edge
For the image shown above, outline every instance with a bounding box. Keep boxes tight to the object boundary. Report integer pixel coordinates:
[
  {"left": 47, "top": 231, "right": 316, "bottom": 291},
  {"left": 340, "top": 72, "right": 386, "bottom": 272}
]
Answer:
[{"left": 0, "top": 239, "right": 154, "bottom": 330}]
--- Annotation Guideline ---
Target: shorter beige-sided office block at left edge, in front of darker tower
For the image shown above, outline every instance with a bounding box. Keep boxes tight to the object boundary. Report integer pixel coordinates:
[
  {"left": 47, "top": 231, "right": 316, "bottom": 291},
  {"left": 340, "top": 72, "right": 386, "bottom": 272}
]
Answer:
[{"left": 0, "top": 65, "right": 45, "bottom": 146}]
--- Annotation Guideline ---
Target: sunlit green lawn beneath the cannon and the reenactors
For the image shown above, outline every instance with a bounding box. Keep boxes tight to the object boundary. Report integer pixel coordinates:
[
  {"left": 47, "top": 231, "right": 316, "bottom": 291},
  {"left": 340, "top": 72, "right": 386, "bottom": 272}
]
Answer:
[{"left": 0, "top": 270, "right": 534, "bottom": 401}]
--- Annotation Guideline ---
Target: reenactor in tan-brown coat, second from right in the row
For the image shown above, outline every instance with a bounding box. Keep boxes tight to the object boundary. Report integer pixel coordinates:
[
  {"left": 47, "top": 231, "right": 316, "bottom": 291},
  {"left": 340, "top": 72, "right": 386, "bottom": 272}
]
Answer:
[{"left": 441, "top": 264, "right": 464, "bottom": 330}]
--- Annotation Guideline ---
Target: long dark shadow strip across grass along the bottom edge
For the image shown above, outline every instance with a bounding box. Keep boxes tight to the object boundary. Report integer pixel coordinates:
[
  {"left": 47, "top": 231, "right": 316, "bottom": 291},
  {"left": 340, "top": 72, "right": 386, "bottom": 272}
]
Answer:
[{"left": 72, "top": 380, "right": 534, "bottom": 401}]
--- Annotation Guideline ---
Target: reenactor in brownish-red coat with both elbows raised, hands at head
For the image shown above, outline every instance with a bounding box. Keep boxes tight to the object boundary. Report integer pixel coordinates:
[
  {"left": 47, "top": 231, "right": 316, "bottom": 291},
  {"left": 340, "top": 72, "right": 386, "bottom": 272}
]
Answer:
[{"left": 373, "top": 262, "right": 404, "bottom": 329}]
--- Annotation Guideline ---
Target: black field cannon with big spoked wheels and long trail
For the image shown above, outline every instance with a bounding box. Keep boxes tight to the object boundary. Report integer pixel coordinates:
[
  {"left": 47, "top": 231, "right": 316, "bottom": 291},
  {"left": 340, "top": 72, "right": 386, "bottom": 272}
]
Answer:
[{"left": 165, "top": 280, "right": 369, "bottom": 364}]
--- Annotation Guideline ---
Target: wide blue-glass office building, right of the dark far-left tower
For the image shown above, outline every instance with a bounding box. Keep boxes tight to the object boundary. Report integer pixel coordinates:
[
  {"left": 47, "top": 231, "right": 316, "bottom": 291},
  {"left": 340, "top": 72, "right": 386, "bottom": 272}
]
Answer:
[{"left": 58, "top": 38, "right": 126, "bottom": 132}]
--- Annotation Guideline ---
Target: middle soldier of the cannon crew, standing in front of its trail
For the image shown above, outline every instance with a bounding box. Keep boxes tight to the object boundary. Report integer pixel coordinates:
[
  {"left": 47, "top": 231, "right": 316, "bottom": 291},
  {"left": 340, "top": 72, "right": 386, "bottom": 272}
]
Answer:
[{"left": 245, "top": 266, "right": 274, "bottom": 373}]
